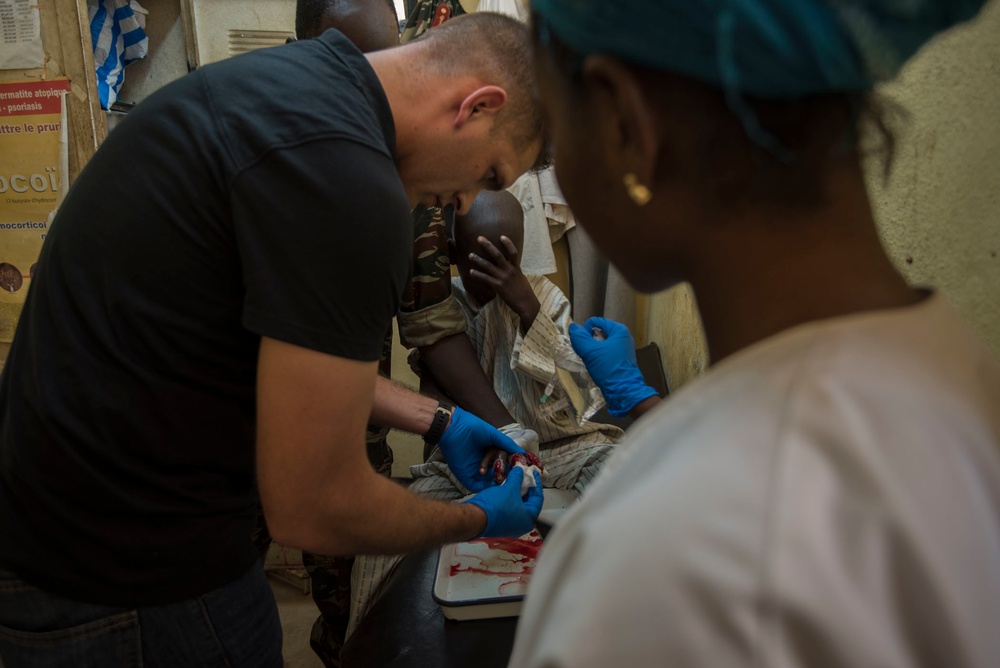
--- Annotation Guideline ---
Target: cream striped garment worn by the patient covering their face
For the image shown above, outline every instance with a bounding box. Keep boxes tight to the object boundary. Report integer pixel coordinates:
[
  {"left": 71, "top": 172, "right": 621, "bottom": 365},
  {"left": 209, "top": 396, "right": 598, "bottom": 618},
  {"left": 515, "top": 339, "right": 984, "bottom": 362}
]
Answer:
[{"left": 347, "top": 276, "right": 625, "bottom": 637}]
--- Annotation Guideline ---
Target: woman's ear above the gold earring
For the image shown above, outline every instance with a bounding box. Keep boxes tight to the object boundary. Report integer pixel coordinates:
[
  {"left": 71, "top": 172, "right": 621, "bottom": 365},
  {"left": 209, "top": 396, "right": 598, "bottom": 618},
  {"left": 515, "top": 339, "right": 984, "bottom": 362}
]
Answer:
[{"left": 583, "top": 56, "right": 662, "bottom": 186}]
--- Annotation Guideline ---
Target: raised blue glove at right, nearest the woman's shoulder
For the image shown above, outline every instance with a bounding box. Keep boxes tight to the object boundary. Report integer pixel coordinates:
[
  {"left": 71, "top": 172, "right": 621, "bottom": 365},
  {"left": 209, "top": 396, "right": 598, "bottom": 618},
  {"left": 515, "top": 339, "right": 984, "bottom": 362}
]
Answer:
[{"left": 569, "top": 318, "right": 656, "bottom": 417}]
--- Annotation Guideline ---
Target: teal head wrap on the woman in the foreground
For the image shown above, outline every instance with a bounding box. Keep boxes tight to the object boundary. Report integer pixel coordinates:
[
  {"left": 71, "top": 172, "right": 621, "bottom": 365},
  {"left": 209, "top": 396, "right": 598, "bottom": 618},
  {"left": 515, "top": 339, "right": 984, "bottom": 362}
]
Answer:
[{"left": 532, "top": 0, "right": 985, "bottom": 99}]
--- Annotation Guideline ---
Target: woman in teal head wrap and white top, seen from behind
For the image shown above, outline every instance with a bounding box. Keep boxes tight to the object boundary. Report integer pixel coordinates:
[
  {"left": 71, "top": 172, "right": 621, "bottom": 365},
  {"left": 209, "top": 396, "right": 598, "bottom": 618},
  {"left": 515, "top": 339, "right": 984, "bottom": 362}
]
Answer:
[{"left": 510, "top": 0, "right": 1000, "bottom": 668}]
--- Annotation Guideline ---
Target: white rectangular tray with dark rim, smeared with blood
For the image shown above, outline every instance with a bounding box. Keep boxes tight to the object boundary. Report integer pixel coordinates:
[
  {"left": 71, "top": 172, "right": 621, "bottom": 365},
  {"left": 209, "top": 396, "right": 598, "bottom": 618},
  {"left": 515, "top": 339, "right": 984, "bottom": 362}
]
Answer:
[{"left": 432, "top": 489, "right": 576, "bottom": 620}]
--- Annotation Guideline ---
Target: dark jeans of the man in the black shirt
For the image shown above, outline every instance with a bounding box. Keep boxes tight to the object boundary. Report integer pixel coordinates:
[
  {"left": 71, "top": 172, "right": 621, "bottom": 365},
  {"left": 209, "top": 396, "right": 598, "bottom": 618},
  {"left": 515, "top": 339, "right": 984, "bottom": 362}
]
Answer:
[{"left": 0, "top": 564, "right": 284, "bottom": 668}]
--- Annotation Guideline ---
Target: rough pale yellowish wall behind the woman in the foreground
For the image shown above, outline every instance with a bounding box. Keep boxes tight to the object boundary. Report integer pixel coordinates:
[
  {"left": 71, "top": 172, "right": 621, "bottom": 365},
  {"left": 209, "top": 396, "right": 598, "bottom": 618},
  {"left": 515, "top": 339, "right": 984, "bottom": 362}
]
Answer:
[{"left": 637, "top": 0, "right": 1000, "bottom": 389}]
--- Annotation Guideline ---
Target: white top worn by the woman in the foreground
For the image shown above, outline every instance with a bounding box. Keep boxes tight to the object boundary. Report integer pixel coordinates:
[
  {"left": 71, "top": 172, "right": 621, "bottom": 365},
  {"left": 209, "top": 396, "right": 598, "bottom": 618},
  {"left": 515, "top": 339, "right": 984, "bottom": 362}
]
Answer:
[{"left": 510, "top": 295, "right": 1000, "bottom": 668}]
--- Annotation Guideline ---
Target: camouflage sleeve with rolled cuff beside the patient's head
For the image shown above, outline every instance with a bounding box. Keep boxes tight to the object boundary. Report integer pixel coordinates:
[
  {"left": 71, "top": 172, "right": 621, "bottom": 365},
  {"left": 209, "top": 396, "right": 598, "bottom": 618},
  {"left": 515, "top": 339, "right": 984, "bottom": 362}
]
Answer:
[{"left": 396, "top": 207, "right": 465, "bottom": 348}]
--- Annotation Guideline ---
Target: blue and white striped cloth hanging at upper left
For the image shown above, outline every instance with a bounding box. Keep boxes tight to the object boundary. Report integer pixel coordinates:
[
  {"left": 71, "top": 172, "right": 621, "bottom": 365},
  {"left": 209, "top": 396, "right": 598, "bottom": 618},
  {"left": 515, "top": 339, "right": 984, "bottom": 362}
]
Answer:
[{"left": 87, "top": 0, "right": 149, "bottom": 109}]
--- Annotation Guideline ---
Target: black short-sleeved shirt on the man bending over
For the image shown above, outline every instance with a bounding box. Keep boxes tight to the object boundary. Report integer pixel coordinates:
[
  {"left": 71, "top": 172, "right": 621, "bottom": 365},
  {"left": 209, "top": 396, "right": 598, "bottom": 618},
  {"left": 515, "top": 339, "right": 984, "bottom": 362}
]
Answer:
[{"left": 0, "top": 31, "right": 413, "bottom": 606}]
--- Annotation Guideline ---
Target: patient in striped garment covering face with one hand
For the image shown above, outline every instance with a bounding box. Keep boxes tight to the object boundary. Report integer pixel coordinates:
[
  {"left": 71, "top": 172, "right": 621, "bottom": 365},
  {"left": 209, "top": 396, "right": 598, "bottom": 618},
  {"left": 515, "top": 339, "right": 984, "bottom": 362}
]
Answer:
[{"left": 348, "top": 191, "right": 624, "bottom": 635}]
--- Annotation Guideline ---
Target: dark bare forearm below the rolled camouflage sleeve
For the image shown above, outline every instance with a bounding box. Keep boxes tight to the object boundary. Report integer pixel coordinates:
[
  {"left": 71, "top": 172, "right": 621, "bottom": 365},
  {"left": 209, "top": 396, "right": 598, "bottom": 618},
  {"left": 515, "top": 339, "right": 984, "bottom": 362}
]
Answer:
[{"left": 420, "top": 333, "right": 515, "bottom": 427}]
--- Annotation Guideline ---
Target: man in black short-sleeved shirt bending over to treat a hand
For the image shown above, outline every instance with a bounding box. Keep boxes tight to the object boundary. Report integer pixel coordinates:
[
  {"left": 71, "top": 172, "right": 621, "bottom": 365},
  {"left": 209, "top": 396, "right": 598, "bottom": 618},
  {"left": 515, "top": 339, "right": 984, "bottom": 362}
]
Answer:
[{"left": 0, "top": 15, "right": 542, "bottom": 668}]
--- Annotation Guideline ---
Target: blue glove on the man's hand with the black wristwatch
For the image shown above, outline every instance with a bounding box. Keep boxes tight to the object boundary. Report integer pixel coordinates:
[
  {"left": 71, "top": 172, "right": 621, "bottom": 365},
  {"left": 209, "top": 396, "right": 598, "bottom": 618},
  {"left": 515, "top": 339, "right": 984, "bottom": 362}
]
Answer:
[{"left": 438, "top": 406, "right": 524, "bottom": 492}]
